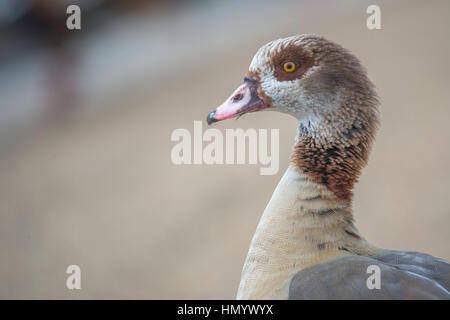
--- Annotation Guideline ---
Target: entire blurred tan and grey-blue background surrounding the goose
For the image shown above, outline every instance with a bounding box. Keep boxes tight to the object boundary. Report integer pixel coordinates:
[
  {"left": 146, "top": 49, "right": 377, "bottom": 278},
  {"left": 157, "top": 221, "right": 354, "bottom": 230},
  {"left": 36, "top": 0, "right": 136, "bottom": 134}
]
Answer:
[{"left": 0, "top": 0, "right": 450, "bottom": 299}]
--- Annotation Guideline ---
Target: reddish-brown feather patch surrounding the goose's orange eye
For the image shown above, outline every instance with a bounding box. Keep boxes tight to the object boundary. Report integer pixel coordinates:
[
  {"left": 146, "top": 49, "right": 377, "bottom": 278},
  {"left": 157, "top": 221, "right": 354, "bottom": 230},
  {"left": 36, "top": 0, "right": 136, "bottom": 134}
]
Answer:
[{"left": 272, "top": 45, "right": 315, "bottom": 81}]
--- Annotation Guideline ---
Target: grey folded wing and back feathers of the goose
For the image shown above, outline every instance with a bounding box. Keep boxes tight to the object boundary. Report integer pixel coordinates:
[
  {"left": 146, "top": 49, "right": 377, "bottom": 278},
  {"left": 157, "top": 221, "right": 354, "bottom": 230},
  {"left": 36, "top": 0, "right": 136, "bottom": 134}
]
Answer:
[{"left": 289, "top": 250, "right": 450, "bottom": 300}]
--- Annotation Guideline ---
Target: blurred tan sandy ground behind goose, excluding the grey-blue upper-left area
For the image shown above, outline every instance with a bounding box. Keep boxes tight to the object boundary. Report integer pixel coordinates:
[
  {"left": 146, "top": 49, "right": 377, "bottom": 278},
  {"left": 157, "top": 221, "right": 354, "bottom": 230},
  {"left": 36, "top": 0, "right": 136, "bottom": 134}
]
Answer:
[{"left": 0, "top": 1, "right": 450, "bottom": 299}]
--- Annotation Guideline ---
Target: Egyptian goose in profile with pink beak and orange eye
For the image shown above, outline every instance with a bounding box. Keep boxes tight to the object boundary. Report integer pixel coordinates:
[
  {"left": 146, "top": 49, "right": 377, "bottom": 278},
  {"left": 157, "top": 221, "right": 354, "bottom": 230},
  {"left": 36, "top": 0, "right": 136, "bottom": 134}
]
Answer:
[{"left": 207, "top": 35, "right": 450, "bottom": 299}]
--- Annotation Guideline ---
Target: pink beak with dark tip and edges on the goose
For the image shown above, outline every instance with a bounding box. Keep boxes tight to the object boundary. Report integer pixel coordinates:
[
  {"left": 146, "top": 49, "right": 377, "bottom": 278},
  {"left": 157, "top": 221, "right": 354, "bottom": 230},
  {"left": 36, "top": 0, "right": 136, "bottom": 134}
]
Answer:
[{"left": 206, "top": 77, "right": 266, "bottom": 125}]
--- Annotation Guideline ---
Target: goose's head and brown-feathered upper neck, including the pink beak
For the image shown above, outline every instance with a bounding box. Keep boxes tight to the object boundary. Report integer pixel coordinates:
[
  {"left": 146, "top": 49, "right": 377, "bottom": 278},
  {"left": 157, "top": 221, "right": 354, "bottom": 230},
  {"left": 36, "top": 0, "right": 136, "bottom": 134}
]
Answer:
[{"left": 207, "top": 35, "right": 378, "bottom": 200}]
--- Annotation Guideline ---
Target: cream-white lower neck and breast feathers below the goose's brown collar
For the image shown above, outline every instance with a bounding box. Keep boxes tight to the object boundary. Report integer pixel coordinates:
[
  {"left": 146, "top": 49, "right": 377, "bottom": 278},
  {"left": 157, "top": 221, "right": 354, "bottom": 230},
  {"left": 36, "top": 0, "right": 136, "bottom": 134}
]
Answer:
[{"left": 237, "top": 165, "right": 376, "bottom": 299}]
